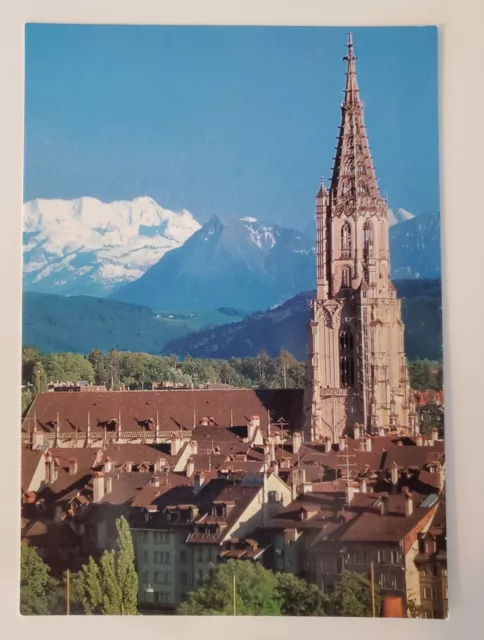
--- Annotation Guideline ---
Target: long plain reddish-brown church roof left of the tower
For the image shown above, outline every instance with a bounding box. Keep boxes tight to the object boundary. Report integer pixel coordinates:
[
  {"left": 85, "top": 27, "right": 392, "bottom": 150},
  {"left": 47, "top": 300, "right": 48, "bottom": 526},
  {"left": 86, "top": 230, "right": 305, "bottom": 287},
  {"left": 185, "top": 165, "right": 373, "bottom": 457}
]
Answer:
[{"left": 23, "top": 389, "right": 303, "bottom": 433}]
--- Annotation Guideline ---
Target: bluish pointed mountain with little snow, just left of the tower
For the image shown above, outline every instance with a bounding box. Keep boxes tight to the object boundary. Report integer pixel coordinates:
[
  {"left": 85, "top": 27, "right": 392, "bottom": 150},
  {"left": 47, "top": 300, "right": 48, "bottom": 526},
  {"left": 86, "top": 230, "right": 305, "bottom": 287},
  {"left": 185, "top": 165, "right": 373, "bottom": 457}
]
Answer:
[{"left": 112, "top": 216, "right": 316, "bottom": 310}]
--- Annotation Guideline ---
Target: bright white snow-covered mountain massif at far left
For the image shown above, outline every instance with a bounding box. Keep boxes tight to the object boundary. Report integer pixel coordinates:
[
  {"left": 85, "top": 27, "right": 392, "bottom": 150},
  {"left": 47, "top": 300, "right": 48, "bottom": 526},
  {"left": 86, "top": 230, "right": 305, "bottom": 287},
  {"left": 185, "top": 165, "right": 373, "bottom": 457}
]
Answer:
[{"left": 23, "top": 197, "right": 200, "bottom": 296}]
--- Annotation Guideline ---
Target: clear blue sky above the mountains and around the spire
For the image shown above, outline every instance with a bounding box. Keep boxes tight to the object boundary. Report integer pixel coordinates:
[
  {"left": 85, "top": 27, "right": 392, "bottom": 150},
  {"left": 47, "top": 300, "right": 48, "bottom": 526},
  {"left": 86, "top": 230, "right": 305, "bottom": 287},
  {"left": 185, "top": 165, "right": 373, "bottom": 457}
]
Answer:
[{"left": 24, "top": 24, "right": 439, "bottom": 228}]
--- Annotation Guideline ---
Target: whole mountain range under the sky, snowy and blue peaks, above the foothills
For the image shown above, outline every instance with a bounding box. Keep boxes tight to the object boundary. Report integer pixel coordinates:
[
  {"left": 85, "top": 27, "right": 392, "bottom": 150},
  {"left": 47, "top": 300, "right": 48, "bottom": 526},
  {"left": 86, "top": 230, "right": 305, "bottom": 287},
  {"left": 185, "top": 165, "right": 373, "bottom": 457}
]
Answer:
[{"left": 24, "top": 197, "right": 440, "bottom": 310}]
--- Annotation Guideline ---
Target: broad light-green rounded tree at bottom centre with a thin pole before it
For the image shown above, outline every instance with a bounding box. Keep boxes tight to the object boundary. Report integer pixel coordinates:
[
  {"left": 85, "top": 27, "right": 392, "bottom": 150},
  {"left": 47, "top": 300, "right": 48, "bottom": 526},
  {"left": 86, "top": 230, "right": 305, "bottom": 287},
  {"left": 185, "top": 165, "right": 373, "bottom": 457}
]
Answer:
[{"left": 178, "top": 560, "right": 281, "bottom": 616}]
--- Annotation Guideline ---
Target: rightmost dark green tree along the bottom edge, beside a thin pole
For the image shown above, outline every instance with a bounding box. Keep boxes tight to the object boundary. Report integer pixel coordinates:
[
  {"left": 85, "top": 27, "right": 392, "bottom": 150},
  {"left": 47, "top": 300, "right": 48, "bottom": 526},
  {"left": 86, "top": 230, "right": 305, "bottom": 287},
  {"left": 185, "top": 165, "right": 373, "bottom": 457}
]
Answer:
[{"left": 328, "top": 571, "right": 381, "bottom": 618}]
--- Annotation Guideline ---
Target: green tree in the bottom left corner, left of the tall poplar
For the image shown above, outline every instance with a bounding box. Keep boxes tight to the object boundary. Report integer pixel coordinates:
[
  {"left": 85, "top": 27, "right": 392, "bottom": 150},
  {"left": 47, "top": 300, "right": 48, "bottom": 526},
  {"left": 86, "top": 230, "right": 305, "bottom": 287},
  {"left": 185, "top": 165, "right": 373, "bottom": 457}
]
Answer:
[{"left": 20, "top": 542, "right": 57, "bottom": 616}]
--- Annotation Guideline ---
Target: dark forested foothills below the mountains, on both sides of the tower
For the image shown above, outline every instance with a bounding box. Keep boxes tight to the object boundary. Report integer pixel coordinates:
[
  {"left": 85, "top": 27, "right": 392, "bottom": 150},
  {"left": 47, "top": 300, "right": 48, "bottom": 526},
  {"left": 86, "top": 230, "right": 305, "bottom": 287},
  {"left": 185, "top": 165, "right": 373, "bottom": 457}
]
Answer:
[{"left": 23, "top": 280, "right": 442, "bottom": 360}]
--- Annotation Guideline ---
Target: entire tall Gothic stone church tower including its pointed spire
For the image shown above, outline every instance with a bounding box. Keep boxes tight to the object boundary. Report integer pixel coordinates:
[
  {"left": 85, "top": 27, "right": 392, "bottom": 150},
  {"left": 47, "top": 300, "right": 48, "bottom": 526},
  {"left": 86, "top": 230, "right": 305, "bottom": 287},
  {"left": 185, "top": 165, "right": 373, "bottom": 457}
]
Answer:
[{"left": 304, "top": 34, "right": 417, "bottom": 442}]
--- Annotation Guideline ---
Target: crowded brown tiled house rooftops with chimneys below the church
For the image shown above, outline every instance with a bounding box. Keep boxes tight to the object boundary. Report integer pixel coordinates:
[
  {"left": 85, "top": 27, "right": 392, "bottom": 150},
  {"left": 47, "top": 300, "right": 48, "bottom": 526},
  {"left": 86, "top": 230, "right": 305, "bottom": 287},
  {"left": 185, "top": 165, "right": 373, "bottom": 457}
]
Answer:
[{"left": 22, "top": 408, "right": 445, "bottom": 543}]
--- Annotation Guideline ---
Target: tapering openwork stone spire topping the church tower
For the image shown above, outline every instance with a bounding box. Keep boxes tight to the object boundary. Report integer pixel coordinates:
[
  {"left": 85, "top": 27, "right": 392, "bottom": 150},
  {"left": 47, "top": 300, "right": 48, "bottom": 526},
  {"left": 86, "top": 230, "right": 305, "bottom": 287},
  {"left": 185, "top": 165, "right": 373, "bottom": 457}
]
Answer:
[{"left": 330, "top": 33, "right": 380, "bottom": 204}]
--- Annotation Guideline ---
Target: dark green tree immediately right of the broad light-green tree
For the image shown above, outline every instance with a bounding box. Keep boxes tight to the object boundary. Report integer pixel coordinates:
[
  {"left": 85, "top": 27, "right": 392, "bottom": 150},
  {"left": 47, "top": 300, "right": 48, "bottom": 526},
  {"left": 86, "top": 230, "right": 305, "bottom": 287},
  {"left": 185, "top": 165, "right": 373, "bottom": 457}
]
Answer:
[{"left": 276, "top": 573, "right": 328, "bottom": 616}]
